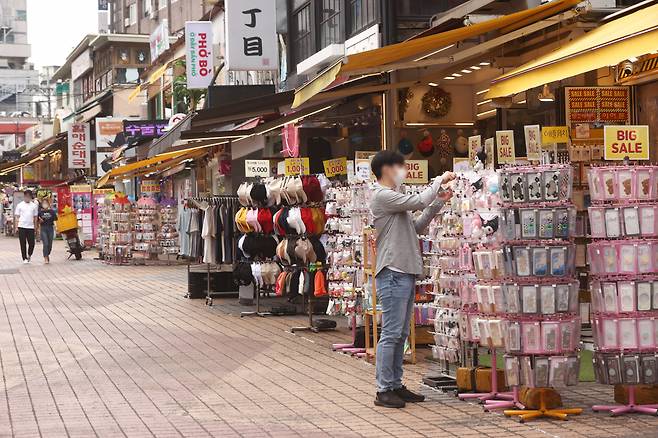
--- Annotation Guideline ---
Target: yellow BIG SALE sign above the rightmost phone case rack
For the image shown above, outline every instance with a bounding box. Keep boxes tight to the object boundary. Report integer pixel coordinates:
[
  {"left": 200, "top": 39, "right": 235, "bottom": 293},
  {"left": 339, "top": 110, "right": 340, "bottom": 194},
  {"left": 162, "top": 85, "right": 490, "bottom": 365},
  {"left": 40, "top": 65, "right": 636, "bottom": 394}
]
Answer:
[{"left": 603, "top": 125, "right": 649, "bottom": 160}]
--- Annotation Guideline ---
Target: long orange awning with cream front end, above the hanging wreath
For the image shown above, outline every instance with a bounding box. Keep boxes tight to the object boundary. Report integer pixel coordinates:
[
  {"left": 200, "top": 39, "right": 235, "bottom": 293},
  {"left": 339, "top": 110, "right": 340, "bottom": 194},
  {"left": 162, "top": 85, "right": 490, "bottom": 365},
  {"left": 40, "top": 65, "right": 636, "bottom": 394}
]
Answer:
[{"left": 292, "top": 0, "right": 580, "bottom": 108}]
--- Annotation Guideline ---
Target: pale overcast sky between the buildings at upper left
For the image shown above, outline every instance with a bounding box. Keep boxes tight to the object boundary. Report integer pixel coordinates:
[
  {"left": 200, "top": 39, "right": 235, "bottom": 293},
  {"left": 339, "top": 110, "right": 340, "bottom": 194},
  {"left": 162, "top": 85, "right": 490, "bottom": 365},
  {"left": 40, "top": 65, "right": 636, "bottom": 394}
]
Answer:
[{"left": 27, "top": 0, "right": 98, "bottom": 68}]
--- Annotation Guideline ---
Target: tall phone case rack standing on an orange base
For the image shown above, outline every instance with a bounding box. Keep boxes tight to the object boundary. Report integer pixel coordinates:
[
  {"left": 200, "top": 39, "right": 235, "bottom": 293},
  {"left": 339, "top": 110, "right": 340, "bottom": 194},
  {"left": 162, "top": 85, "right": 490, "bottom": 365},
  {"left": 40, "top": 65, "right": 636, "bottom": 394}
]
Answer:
[{"left": 494, "top": 164, "right": 582, "bottom": 422}]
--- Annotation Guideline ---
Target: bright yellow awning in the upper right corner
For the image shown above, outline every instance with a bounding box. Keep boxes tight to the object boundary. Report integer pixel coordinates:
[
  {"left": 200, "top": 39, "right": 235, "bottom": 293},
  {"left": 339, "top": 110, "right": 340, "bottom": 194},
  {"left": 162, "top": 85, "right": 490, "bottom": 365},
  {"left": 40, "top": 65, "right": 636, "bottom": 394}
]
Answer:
[{"left": 487, "top": 5, "right": 658, "bottom": 99}]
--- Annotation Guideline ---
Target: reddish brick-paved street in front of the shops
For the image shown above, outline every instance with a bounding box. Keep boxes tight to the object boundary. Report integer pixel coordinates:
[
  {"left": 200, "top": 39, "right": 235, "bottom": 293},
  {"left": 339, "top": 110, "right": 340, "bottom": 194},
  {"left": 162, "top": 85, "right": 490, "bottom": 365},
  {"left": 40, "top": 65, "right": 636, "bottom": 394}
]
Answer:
[{"left": 0, "top": 237, "right": 658, "bottom": 438}]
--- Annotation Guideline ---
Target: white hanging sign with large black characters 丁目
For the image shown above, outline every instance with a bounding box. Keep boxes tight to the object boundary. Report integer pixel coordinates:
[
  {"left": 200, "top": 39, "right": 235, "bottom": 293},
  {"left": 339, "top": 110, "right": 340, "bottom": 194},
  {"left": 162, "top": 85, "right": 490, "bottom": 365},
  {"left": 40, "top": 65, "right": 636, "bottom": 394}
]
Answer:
[{"left": 224, "top": 0, "right": 279, "bottom": 71}]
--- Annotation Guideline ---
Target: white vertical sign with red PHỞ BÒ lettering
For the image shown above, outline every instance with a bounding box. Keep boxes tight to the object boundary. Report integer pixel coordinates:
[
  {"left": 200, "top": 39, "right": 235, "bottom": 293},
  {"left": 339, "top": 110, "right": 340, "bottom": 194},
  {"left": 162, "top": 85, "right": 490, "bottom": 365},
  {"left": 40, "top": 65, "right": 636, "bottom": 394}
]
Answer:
[{"left": 185, "top": 21, "right": 214, "bottom": 90}]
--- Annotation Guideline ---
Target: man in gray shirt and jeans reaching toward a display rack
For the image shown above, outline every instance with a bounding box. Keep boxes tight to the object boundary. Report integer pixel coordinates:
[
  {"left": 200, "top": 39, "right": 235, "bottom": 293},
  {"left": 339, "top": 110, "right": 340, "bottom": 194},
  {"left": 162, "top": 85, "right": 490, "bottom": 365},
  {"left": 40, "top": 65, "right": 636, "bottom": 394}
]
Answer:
[{"left": 370, "top": 151, "right": 455, "bottom": 408}]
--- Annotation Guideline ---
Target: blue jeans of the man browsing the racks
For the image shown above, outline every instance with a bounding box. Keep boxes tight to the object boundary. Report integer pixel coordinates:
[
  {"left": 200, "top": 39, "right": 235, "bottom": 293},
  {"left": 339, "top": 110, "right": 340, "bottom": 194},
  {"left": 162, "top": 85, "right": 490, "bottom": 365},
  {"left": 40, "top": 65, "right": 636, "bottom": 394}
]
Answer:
[{"left": 376, "top": 268, "right": 416, "bottom": 392}]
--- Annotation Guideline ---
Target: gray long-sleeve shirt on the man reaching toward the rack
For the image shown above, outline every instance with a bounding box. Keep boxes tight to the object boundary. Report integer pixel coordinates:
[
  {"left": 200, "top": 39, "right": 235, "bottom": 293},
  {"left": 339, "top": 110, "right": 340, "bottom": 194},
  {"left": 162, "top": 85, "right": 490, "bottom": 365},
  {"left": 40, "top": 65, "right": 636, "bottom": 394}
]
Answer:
[{"left": 370, "top": 182, "right": 443, "bottom": 275}]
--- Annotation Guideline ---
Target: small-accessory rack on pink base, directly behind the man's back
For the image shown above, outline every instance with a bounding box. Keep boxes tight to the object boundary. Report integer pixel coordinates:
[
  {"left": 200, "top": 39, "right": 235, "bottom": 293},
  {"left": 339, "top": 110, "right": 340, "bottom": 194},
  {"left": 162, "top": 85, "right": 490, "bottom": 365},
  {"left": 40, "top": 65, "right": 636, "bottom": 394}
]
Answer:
[{"left": 325, "top": 180, "right": 372, "bottom": 357}]
